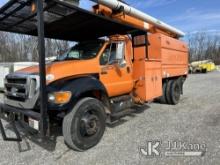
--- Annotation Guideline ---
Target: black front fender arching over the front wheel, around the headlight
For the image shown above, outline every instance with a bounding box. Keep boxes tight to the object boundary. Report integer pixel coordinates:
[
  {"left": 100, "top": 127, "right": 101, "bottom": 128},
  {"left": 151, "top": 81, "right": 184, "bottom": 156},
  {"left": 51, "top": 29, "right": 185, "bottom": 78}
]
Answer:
[{"left": 47, "top": 76, "right": 108, "bottom": 110}]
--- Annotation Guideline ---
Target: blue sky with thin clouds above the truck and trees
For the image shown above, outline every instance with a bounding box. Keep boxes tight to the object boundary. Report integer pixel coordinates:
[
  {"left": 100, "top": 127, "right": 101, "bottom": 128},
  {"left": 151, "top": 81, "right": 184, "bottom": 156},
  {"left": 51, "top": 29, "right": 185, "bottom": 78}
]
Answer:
[{"left": 0, "top": 0, "right": 220, "bottom": 35}]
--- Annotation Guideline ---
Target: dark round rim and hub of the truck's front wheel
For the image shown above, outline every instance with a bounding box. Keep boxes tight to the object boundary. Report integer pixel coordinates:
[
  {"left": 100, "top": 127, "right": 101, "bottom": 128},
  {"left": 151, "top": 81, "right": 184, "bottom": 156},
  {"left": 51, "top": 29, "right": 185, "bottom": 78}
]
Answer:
[{"left": 80, "top": 110, "right": 101, "bottom": 138}]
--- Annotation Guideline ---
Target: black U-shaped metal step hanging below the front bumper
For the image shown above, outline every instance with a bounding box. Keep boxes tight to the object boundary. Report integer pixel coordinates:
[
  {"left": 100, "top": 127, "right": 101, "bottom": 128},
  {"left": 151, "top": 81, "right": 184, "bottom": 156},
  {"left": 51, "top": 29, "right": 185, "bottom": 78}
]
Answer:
[{"left": 0, "top": 119, "right": 22, "bottom": 142}]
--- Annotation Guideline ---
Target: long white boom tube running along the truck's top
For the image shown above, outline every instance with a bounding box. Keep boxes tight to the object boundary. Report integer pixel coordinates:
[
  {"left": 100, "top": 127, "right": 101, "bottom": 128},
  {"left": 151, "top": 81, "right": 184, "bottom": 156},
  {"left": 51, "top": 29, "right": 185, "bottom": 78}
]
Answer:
[{"left": 91, "top": 0, "right": 185, "bottom": 37}]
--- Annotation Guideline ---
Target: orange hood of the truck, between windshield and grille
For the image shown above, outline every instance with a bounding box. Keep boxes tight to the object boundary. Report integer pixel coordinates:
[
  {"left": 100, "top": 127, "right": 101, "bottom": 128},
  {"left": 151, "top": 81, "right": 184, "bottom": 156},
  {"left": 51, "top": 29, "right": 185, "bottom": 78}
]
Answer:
[{"left": 17, "top": 59, "right": 99, "bottom": 83}]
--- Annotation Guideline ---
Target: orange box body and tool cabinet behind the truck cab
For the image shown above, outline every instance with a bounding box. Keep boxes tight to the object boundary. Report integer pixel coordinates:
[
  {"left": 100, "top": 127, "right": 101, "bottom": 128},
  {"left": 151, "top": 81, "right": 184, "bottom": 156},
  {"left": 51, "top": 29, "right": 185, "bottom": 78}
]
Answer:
[{"left": 134, "top": 33, "right": 188, "bottom": 101}]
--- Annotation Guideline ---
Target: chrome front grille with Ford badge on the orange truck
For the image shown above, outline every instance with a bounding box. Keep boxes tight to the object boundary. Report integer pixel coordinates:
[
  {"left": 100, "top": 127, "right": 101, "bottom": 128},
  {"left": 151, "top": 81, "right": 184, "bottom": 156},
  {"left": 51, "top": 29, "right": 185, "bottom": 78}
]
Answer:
[{"left": 5, "top": 75, "right": 37, "bottom": 102}]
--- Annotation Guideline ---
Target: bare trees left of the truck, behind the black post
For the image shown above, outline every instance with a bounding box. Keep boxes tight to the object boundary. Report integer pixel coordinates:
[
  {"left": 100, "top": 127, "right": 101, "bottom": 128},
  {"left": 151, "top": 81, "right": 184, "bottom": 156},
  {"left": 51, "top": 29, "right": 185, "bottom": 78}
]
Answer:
[{"left": 0, "top": 32, "right": 70, "bottom": 62}]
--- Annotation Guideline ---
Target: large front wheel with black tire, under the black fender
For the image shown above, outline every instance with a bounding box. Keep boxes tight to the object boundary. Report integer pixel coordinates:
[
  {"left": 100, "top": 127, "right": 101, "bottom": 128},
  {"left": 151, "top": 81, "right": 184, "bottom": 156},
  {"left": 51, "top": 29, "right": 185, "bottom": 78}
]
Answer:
[{"left": 63, "top": 98, "right": 106, "bottom": 151}]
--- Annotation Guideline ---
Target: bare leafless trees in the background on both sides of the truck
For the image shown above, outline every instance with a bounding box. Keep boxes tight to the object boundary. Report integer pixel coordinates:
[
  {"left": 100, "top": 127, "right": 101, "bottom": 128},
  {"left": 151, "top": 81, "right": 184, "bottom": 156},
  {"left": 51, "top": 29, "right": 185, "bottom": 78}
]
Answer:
[{"left": 0, "top": 32, "right": 220, "bottom": 64}]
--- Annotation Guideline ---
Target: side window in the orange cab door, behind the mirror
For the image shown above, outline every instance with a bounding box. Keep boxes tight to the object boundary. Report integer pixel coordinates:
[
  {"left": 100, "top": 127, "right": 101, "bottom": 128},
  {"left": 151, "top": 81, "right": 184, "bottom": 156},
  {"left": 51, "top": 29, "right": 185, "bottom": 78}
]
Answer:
[{"left": 100, "top": 42, "right": 125, "bottom": 65}]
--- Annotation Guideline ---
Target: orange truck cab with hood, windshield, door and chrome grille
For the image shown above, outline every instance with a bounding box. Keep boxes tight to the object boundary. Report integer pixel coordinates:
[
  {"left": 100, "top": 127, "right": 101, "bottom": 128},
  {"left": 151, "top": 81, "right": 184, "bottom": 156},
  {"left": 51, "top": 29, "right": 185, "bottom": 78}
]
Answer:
[{"left": 5, "top": 36, "right": 134, "bottom": 109}]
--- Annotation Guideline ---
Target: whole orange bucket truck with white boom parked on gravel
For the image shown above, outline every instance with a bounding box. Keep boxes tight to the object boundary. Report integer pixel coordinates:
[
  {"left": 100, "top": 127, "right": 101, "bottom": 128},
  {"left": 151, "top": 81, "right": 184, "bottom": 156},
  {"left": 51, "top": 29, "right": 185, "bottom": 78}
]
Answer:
[{"left": 0, "top": 0, "right": 188, "bottom": 151}]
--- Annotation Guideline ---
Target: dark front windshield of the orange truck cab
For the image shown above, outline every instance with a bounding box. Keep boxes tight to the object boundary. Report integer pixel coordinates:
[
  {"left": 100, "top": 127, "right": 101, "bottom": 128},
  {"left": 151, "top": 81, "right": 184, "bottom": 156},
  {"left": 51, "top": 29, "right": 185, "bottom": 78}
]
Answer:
[{"left": 57, "top": 40, "right": 104, "bottom": 61}]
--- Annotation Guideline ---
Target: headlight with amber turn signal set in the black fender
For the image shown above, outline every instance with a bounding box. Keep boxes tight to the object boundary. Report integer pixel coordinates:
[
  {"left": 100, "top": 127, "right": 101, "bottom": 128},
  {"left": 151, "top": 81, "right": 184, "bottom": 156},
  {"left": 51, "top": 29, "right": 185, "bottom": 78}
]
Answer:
[{"left": 48, "top": 91, "right": 72, "bottom": 104}]
